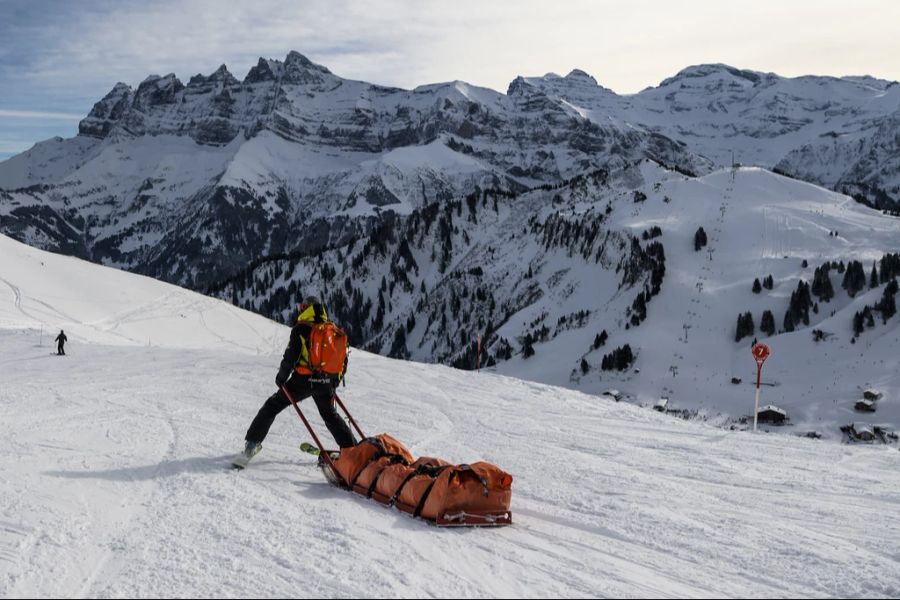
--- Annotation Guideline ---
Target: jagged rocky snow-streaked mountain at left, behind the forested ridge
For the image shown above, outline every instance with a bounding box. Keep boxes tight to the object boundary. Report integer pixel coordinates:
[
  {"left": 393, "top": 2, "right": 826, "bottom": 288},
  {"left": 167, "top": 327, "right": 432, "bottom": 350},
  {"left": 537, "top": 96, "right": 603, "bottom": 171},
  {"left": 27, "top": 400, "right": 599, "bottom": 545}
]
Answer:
[{"left": 0, "top": 52, "right": 710, "bottom": 285}]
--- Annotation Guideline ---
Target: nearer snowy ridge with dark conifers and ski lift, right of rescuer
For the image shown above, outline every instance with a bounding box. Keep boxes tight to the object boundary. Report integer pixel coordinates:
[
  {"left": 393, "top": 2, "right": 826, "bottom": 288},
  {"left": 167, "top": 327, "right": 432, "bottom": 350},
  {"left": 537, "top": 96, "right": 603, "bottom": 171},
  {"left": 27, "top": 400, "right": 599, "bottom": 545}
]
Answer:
[{"left": 216, "top": 161, "right": 900, "bottom": 438}]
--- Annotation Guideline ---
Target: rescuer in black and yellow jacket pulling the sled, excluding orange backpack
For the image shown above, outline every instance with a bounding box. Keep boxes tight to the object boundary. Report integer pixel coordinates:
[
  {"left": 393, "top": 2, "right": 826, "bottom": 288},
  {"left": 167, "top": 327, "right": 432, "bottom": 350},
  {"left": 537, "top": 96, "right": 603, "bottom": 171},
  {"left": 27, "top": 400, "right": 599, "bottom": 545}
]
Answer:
[{"left": 234, "top": 296, "right": 356, "bottom": 467}]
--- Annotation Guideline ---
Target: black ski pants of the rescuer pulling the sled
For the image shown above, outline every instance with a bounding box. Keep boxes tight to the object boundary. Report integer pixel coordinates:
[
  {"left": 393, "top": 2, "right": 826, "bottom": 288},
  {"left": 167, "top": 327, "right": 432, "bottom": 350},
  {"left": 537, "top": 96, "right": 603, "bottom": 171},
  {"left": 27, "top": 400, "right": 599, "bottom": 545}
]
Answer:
[{"left": 244, "top": 373, "right": 356, "bottom": 448}]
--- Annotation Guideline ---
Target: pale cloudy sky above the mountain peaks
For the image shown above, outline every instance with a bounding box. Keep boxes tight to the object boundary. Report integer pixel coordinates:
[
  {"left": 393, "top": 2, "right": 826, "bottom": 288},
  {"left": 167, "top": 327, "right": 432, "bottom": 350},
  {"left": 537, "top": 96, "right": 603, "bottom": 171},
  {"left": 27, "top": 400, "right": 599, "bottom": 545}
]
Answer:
[{"left": 0, "top": 0, "right": 900, "bottom": 160}]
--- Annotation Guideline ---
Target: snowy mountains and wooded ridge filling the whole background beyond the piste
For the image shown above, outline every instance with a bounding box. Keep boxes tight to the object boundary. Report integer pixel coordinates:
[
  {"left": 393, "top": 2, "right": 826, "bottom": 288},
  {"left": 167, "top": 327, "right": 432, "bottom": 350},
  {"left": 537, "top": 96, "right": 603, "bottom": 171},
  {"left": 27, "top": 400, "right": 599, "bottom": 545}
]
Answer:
[{"left": 0, "top": 52, "right": 900, "bottom": 420}]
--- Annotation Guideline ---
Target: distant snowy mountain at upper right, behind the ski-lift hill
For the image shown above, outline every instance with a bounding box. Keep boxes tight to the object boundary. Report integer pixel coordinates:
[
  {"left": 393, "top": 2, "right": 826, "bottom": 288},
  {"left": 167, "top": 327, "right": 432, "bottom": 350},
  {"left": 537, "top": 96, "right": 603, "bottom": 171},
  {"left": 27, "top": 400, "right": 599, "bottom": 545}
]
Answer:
[{"left": 512, "top": 64, "right": 900, "bottom": 189}]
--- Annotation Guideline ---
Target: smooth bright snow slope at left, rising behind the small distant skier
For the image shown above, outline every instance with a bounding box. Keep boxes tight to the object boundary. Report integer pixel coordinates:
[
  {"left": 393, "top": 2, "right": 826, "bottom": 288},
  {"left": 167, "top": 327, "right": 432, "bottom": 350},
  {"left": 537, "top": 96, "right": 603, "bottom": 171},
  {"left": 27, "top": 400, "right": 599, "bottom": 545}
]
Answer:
[{"left": 0, "top": 235, "right": 284, "bottom": 354}]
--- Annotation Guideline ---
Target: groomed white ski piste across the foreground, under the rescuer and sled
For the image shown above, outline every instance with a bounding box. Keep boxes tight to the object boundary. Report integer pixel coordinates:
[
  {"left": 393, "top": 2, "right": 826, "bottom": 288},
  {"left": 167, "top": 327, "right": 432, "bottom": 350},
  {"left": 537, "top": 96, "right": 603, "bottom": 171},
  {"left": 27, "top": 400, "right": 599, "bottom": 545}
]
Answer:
[{"left": 0, "top": 237, "right": 900, "bottom": 598}]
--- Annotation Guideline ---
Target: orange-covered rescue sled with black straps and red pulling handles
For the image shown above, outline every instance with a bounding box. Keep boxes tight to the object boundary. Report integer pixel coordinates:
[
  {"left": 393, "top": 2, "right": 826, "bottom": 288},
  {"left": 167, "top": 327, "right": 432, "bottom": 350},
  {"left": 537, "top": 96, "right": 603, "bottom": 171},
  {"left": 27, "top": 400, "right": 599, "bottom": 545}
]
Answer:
[{"left": 281, "top": 386, "right": 513, "bottom": 527}]
